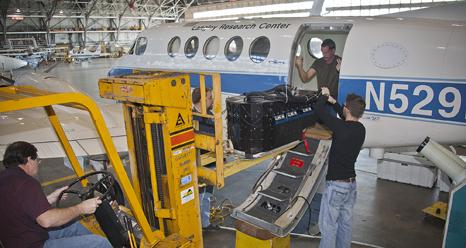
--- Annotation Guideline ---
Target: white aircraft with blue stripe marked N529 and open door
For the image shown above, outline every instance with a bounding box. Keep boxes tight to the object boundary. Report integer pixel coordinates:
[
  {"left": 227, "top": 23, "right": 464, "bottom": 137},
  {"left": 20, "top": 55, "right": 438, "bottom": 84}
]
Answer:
[{"left": 0, "top": 4, "right": 466, "bottom": 160}]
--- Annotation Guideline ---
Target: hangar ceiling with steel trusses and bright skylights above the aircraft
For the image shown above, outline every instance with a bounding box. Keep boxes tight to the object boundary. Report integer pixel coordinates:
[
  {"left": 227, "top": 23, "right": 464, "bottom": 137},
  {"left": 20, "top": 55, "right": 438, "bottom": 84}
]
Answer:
[{"left": 0, "top": 0, "right": 464, "bottom": 47}]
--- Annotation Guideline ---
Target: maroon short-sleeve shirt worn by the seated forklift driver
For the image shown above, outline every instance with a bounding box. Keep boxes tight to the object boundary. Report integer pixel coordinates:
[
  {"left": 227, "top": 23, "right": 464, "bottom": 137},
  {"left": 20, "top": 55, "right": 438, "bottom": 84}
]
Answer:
[{"left": 0, "top": 167, "right": 51, "bottom": 247}]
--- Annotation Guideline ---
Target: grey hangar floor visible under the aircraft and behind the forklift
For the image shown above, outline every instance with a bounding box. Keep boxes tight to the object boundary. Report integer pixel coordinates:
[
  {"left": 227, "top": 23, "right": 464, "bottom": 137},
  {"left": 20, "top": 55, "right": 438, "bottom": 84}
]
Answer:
[{"left": 2, "top": 59, "right": 447, "bottom": 248}]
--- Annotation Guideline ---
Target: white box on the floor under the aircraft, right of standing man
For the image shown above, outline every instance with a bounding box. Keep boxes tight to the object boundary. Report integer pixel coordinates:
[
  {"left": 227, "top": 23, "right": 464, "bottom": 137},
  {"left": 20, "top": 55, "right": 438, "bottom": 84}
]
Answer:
[{"left": 377, "top": 153, "right": 437, "bottom": 188}]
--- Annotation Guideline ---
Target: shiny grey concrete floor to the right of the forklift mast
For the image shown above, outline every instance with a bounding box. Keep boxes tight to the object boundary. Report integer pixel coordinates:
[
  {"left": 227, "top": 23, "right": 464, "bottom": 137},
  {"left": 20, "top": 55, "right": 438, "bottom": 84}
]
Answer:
[{"left": 204, "top": 154, "right": 447, "bottom": 248}]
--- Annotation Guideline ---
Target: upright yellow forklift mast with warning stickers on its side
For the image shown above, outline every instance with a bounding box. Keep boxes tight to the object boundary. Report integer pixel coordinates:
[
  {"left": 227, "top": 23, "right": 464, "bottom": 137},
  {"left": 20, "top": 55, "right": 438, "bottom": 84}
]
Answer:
[{"left": 99, "top": 72, "right": 203, "bottom": 247}]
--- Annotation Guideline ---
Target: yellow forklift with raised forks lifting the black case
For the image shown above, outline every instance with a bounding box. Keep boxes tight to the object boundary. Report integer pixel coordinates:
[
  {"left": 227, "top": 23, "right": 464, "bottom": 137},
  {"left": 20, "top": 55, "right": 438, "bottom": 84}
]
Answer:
[{"left": 0, "top": 72, "right": 314, "bottom": 247}]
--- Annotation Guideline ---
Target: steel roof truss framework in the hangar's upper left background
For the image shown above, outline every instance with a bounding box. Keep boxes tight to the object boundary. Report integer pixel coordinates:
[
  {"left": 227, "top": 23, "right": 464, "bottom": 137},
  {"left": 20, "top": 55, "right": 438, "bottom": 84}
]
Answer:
[{"left": 0, "top": 0, "right": 194, "bottom": 45}]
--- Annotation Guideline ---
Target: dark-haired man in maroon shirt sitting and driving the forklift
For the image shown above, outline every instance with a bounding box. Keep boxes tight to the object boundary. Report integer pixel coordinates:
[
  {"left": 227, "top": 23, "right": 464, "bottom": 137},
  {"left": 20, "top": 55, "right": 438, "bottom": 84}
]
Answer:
[{"left": 0, "top": 141, "right": 112, "bottom": 248}]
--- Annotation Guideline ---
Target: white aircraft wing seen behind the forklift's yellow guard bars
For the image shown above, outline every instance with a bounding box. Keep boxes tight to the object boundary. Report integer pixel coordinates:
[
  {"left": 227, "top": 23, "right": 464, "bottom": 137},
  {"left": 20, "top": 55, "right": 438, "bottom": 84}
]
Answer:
[{"left": 0, "top": 104, "right": 128, "bottom": 160}]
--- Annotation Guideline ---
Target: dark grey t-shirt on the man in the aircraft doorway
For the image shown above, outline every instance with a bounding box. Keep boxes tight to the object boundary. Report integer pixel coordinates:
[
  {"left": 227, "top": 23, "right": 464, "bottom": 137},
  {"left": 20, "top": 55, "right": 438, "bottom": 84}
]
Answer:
[{"left": 311, "top": 55, "right": 341, "bottom": 100}]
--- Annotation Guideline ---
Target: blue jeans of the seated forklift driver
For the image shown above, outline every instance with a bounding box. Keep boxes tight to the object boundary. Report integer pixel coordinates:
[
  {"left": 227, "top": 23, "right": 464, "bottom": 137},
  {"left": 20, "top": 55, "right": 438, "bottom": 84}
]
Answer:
[{"left": 44, "top": 221, "right": 112, "bottom": 248}]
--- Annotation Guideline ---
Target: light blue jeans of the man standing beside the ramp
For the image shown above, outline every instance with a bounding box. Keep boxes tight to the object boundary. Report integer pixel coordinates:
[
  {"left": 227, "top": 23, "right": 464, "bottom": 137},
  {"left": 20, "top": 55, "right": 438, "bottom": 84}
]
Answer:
[{"left": 319, "top": 181, "right": 356, "bottom": 248}]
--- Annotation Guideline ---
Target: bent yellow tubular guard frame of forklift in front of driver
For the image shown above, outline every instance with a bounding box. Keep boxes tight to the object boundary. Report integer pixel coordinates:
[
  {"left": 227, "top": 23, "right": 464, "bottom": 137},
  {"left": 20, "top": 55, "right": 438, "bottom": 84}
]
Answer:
[{"left": 0, "top": 86, "right": 164, "bottom": 246}]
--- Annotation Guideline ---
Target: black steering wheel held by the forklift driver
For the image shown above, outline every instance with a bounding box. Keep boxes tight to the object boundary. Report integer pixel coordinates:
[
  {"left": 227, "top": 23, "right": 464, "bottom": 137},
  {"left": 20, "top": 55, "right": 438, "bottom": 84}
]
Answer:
[{"left": 56, "top": 171, "right": 115, "bottom": 208}]
